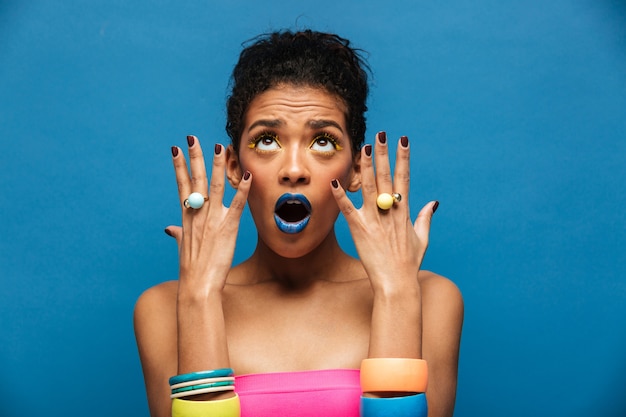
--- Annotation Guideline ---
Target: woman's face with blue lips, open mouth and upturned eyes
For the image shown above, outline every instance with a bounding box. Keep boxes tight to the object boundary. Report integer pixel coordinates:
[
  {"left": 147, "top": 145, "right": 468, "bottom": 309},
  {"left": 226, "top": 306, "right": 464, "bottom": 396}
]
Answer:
[{"left": 228, "top": 85, "right": 360, "bottom": 258}]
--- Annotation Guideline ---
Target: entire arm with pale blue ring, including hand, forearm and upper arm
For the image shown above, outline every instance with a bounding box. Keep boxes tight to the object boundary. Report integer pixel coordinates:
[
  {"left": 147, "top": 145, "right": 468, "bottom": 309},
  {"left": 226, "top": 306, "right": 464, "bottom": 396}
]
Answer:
[{"left": 135, "top": 136, "right": 251, "bottom": 416}]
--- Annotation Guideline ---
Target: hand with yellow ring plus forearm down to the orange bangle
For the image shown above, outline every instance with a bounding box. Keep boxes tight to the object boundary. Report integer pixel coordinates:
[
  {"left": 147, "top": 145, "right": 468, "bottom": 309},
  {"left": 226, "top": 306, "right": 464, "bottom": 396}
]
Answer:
[{"left": 331, "top": 132, "right": 437, "bottom": 358}]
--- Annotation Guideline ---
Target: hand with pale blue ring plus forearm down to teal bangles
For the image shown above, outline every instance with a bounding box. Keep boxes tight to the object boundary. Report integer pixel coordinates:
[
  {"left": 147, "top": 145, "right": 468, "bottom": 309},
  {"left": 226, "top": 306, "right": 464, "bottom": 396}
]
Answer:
[{"left": 172, "top": 136, "right": 250, "bottom": 380}]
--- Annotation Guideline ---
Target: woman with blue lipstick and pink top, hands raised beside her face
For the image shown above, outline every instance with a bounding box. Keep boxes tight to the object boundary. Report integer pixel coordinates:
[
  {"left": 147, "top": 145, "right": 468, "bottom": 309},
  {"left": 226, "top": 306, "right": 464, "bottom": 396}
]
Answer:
[{"left": 135, "top": 31, "right": 463, "bottom": 416}]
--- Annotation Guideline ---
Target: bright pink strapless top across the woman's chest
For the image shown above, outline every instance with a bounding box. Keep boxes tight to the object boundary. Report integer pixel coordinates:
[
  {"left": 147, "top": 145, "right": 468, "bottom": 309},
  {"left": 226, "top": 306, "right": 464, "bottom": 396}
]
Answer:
[{"left": 235, "top": 369, "right": 361, "bottom": 417}]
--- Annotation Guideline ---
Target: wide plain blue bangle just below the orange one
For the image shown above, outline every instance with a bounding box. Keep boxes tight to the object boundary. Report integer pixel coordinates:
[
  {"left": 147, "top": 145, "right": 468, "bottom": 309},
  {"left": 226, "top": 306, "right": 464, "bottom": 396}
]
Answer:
[{"left": 361, "top": 393, "right": 428, "bottom": 417}]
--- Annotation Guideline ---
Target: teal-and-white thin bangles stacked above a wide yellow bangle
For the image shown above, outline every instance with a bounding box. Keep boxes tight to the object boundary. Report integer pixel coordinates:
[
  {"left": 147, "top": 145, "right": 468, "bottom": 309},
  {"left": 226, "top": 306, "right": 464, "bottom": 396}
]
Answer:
[{"left": 170, "top": 368, "right": 241, "bottom": 417}]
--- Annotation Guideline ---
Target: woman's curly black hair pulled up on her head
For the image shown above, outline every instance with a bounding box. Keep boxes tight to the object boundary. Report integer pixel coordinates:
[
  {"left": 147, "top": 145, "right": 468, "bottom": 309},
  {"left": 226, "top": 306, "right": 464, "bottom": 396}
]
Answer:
[{"left": 226, "top": 30, "right": 369, "bottom": 153}]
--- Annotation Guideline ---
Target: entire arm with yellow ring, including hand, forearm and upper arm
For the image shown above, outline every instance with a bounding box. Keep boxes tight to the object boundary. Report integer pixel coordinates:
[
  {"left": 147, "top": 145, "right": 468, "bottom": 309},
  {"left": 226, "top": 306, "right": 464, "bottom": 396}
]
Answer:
[{"left": 334, "top": 132, "right": 463, "bottom": 416}]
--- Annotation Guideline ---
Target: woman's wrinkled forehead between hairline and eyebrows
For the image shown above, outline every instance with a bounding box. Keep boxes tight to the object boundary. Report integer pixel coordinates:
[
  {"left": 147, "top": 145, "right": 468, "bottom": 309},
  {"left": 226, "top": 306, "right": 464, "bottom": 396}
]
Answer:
[{"left": 244, "top": 84, "right": 346, "bottom": 131}]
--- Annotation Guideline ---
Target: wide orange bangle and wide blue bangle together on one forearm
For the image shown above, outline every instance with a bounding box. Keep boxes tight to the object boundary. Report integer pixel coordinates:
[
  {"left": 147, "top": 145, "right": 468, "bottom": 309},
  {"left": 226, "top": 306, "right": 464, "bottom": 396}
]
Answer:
[{"left": 361, "top": 358, "right": 428, "bottom": 417}]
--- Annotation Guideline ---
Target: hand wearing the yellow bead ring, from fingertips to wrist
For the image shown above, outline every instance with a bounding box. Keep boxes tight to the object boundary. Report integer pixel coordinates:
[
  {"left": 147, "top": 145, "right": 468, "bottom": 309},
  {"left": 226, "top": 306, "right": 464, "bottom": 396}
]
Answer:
[{"left": 332, "top": 132, "right": 438, "bottom": 291}]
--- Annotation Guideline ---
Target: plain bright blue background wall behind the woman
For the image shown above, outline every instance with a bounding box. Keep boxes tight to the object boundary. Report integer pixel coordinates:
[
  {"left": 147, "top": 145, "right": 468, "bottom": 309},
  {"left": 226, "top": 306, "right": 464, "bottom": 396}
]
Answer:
[{"left": 0, "top": 0, "right": 626, "bottom": 417}]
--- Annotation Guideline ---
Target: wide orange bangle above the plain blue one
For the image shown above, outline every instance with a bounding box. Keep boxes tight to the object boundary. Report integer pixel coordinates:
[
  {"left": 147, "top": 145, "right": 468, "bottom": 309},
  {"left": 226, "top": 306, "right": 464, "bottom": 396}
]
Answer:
[{"left": 361, "top": 358, "right": 428, "bottom": 393}]
